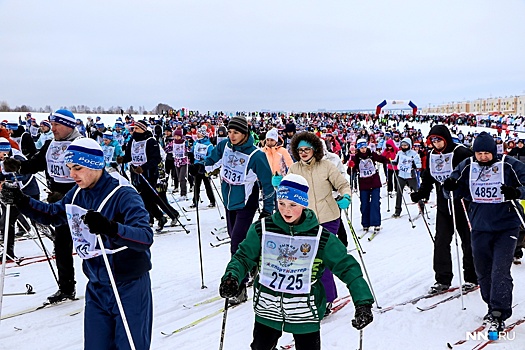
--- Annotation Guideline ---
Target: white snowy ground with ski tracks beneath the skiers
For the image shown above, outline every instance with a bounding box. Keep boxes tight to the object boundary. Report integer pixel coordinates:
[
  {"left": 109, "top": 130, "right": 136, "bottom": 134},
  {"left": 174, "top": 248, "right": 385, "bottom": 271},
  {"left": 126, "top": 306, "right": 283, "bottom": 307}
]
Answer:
[{"left": 0, "top": 124, "right": 525, "bottom": 350}]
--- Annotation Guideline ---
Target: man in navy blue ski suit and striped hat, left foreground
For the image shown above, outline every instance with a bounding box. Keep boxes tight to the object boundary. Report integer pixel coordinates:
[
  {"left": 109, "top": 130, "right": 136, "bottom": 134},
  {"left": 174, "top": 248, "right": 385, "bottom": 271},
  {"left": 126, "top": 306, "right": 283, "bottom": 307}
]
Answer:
[{"left": 1, "top": 138, "right": 153, "bottom": 350}]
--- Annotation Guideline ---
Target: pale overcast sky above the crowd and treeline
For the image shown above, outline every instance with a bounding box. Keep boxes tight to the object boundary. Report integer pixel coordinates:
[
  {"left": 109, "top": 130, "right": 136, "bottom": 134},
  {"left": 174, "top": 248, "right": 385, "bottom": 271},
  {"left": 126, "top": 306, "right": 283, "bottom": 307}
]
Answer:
[{"left": 0, "top": 0, "right": 525, "bottom": 111}]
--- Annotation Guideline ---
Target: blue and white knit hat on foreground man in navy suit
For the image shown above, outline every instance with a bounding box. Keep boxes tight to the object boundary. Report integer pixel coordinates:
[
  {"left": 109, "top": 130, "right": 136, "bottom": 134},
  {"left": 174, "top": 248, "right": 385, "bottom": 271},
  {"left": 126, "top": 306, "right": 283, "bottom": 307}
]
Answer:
[{"left": 64, "top": 138, "right": 104, "bottom": 170}]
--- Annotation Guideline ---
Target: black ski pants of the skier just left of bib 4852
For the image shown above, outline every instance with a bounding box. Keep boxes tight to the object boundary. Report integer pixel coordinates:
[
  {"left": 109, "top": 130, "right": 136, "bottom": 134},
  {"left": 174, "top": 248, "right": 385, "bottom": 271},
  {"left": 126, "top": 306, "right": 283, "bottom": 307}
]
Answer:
[{"left": 434, "top": 195, "right": 478, "bottom": 285}]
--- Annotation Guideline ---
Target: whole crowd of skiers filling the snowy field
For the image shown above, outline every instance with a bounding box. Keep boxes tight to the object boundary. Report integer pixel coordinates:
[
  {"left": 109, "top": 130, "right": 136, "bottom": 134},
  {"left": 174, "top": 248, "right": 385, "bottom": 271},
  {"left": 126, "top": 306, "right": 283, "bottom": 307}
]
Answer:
[{"left": 0, "top": 110, "right": 525, "bottom": 350}]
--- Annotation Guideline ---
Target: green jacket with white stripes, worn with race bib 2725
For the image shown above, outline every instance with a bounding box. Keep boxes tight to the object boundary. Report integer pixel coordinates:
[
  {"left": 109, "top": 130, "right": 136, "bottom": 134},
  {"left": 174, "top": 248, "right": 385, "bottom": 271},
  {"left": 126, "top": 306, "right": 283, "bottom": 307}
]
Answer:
[{"left": 222, "top": 209, "right": 374, "bottom": 334}]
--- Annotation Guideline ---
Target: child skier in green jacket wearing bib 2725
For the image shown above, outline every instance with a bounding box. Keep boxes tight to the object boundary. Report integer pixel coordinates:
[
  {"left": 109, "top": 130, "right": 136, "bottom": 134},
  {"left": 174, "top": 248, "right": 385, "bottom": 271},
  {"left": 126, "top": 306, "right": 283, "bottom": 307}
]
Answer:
[{"left": 219, "top": 174, "right": 374, "bottom": 350}]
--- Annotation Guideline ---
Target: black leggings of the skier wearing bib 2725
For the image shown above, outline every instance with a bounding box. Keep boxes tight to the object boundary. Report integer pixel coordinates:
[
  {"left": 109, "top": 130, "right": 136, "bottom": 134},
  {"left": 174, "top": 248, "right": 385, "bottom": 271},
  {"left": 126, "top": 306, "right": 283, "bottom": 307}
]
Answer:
[{"left": 250, "top": 321, "right": 321, "bottom": 350}]
